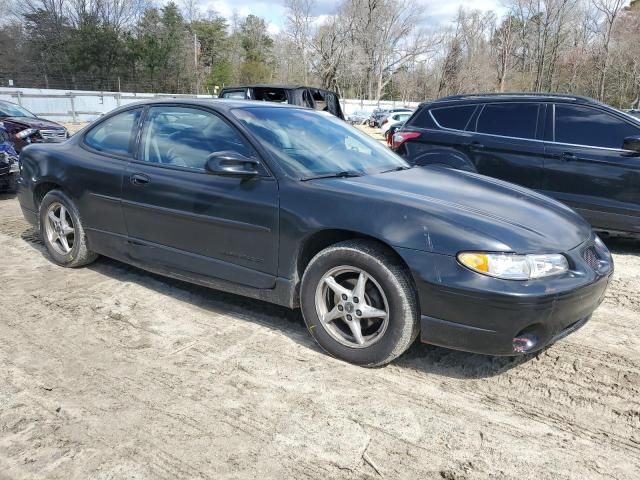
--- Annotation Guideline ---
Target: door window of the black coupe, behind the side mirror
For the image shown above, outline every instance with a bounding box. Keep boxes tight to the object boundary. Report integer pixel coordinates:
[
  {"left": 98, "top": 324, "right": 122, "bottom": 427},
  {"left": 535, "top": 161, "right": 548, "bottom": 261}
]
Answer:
[{"left": 139, "top": 106, "right": 256, "bottom": 171}]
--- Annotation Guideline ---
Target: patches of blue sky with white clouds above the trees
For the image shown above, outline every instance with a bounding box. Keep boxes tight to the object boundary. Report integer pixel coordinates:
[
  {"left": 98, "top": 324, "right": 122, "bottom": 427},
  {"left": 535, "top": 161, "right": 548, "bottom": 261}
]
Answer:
[{"left": 195, "top": 0, "right": 502, "bottom": 33}]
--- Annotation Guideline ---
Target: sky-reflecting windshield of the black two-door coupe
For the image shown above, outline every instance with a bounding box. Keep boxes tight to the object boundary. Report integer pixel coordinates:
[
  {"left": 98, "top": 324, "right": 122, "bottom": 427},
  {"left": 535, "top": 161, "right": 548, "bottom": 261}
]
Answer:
[{"left": 232, "top": 107, "right": 409, "bottom": 179}]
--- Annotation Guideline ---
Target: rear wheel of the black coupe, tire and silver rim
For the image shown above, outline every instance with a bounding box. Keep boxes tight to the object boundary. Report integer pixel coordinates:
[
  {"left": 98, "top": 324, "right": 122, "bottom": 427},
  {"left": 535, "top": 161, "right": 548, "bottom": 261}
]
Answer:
[{"left": 39, "top": 190, "right": 98, "bottom": 268}]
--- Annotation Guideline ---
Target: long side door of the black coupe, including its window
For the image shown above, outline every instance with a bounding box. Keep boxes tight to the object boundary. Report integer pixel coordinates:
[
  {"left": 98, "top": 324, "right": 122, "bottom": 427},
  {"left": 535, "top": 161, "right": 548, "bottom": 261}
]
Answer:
[{"left": 123, "top": 105, "right": 278, "bottom": 288}]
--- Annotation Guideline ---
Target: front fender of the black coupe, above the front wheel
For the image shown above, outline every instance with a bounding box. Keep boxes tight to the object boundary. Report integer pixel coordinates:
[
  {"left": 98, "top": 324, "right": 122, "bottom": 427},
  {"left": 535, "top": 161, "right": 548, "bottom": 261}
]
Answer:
[{"left": 280, "top": 180, "right": 510, "bottom": 278}]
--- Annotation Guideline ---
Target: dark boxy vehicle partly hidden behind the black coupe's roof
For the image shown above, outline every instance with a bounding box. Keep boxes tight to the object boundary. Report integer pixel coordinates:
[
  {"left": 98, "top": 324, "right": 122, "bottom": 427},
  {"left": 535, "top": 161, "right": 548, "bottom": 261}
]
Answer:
[{"left": 219, "top": 85, "right": 344, "bottom": 120}]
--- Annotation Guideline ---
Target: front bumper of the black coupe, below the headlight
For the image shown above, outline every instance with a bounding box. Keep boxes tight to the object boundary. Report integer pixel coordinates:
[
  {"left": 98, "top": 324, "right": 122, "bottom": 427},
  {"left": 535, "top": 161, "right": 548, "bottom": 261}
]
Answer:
[{"left": 399, "top": 240, "right": 613, "bottom": 355}]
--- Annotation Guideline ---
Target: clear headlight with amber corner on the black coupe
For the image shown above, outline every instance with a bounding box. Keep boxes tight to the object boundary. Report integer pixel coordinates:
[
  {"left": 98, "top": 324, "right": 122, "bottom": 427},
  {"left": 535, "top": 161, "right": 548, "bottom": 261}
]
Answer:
[{"left": 458, "top": 252, "right": 569, "bottom": 280}]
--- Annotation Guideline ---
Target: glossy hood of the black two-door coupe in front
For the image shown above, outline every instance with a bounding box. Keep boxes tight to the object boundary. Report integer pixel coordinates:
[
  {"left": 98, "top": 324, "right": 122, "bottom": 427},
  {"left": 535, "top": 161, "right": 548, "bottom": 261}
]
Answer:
[{"left": 322, "top": 167, "right": 592, "bottom": 255}]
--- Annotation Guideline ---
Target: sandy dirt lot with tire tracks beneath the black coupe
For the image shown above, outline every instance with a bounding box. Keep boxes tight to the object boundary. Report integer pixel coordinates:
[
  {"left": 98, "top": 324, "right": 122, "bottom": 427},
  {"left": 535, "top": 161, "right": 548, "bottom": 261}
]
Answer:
[{"left": 0, "top": 171, "right": 640, "bottom": 480}]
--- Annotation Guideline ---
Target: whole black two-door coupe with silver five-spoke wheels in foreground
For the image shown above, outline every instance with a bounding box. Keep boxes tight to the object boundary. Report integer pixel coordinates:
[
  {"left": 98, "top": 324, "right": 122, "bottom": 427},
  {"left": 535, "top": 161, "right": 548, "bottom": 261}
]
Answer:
[{"left": 18, "top": 99, "right": 613, "bottom": 366}]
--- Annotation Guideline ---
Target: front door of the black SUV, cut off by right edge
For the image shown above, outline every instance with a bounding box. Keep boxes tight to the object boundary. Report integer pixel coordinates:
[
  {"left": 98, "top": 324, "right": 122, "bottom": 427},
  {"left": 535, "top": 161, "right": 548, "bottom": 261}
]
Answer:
[{"left": 543, "top": 103, "right": 640, "bottom": 232}]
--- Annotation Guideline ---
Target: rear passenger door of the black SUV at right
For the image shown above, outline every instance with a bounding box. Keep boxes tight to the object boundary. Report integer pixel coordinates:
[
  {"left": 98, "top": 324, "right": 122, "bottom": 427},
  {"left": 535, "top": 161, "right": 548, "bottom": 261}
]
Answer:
[{"left": 467, "top": 102, "right": 544, "bottom": 189}]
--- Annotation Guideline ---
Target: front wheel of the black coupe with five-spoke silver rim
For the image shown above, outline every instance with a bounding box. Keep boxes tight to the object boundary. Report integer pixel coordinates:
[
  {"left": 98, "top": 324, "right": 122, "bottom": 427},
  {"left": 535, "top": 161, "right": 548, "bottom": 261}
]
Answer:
[{"left": 300, "top": 240, "right": 420, "bottom": 367}]
